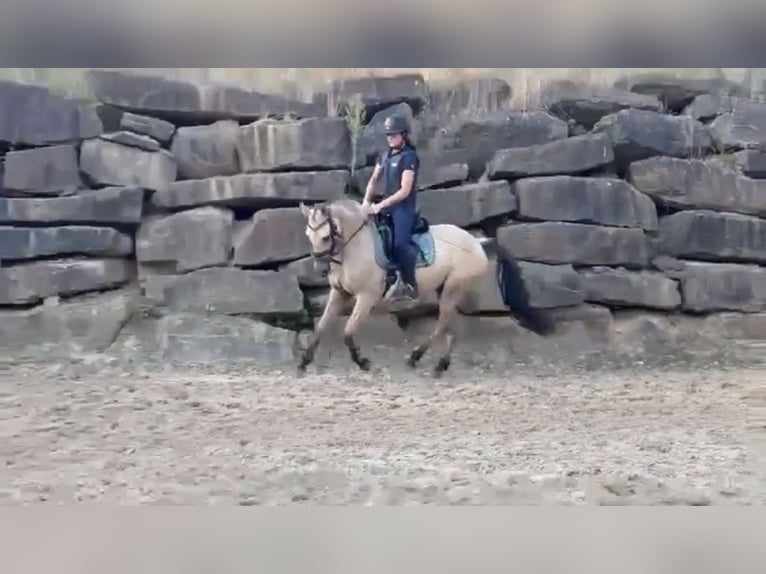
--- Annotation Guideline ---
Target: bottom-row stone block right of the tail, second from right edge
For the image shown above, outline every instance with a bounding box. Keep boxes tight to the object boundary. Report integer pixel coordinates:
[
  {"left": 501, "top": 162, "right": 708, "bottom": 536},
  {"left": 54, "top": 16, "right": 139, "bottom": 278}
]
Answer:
[{"left": 580, "top": 267, "right": 681, "bottom": 310}]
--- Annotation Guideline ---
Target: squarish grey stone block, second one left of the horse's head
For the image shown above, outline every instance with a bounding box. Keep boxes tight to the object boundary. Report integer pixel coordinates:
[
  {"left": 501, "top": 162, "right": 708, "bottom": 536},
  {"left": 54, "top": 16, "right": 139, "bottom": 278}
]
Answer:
[{"left": 136, "top": 207, "right": 234, "bottom": 273}]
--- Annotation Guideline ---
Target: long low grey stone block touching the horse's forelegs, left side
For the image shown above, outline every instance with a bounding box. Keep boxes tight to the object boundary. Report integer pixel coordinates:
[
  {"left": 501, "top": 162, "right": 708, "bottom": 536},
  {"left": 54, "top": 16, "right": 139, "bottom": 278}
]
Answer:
[{"left": 144, "top": 267, "right": 304, "bottom": 316}]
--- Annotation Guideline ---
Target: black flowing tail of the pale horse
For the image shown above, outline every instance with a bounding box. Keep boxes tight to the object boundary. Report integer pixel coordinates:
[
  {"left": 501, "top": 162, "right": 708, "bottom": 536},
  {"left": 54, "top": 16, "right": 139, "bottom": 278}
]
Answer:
[{"left": 485, "top": 242, "right": 556, "bottom": 336}]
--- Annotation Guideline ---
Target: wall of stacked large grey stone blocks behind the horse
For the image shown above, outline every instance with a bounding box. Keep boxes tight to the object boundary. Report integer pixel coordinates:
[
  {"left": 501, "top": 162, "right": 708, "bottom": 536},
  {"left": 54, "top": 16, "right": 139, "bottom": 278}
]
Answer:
[{"left": 0, "top": 71, "right": 766, "bottom": 363}]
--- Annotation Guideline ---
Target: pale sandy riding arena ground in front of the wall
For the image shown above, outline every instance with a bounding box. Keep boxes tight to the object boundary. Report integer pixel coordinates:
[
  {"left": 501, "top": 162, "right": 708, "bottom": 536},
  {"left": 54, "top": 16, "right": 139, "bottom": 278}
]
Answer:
[{"left": 0, "top": 344, "right": 766, "bottom": 505}]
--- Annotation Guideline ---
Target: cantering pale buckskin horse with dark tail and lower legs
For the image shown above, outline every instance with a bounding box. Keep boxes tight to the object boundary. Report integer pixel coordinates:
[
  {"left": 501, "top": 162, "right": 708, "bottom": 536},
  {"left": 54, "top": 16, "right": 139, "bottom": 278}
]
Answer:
[{"left": 298, "top": 199, "right": 555, "bottom": 378}]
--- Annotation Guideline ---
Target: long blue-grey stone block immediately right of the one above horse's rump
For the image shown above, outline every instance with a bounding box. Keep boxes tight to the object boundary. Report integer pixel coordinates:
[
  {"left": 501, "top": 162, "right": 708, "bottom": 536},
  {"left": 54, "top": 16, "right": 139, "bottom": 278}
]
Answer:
[{"left": 512, "top": 175, "right": 657, "bottom": 231}]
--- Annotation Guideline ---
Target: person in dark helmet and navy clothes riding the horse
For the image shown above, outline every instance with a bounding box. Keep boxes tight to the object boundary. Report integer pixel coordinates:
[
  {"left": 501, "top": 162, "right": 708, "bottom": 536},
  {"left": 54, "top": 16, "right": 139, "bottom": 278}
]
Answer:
[{"left": 362, "top": 116, "right": 420, "bottom": 299}]
